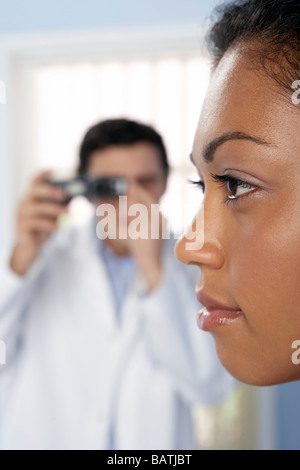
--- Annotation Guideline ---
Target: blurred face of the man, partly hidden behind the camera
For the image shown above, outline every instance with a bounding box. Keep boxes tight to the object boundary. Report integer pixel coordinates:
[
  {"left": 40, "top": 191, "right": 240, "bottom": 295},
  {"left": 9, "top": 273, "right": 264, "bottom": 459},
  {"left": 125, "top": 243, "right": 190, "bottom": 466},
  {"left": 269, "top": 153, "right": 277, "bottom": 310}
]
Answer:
[{"left": 87, "top": 142, "right": 167, "bottom": 248}]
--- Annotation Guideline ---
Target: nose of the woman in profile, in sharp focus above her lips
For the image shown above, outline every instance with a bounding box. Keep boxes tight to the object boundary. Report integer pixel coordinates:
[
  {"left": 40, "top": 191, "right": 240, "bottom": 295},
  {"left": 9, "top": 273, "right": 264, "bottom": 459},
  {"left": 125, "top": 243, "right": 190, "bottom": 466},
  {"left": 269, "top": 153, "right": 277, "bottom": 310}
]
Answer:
[{"left": 175, "top": 205, "right": 225, "bottom": 269}]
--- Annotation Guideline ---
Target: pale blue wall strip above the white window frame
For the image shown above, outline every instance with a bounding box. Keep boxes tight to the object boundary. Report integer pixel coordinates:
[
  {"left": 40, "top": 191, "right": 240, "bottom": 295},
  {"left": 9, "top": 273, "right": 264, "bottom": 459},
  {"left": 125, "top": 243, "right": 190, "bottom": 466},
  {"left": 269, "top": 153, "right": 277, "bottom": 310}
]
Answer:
[{"left": 0, "top": 0, "right": 216, "bottom": 33}]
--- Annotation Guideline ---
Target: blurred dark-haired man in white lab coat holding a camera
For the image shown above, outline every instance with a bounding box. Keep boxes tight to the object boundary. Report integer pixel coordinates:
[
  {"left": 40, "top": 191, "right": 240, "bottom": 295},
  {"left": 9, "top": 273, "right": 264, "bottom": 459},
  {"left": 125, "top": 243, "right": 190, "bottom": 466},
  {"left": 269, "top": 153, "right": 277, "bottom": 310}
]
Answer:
[{"left": 0, "top": 120, "right": 233, "bottom": 449}]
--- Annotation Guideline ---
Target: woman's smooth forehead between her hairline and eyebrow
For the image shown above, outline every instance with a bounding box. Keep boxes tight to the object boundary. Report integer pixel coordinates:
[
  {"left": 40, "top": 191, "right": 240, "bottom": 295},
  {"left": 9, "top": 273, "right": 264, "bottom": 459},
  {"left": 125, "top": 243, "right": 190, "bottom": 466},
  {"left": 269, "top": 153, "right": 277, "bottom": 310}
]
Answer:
[{"left": 195, "top": 49, "right": 300, "bottom": 160}]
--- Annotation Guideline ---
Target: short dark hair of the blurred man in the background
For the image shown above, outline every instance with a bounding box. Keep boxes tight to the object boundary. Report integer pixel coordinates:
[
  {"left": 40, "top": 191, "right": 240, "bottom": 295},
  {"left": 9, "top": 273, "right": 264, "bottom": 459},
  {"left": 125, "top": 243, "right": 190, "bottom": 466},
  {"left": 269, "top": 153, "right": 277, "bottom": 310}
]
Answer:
[{"left": 79, "top": 119, "right": 169, "bottom": 175}]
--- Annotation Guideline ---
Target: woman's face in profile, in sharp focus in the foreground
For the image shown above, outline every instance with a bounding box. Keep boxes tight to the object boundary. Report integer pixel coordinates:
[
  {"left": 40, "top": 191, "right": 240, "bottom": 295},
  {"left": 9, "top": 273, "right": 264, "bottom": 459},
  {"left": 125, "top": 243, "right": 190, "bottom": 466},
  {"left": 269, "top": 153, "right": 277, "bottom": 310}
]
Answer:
[{"left": 176, "top": 49, "right": 300, "bottom": 385}]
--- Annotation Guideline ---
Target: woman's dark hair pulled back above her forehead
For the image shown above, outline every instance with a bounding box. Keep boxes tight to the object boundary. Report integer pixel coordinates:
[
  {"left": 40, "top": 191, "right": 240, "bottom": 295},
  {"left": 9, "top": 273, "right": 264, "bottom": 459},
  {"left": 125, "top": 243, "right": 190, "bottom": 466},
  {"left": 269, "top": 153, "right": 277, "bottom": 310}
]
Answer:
[{"left": 208, "top": 0, "right": 300, "bottom": 95}]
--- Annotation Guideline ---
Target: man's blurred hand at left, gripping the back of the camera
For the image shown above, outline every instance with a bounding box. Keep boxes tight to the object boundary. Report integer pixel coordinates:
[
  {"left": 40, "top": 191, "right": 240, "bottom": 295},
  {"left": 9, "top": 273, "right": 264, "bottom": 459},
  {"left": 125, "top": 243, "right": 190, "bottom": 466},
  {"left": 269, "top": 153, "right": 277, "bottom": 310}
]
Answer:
[{"left": 10, "top": 171, "right": 67, "bottom": 276}]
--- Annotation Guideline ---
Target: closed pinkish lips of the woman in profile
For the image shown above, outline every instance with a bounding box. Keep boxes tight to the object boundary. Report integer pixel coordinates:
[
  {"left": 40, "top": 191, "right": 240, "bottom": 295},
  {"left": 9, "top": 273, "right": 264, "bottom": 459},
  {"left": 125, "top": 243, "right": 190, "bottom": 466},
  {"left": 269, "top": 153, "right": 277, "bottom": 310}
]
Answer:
[{"left": 196, "top": 292, "right": 244, "bottom": 331}]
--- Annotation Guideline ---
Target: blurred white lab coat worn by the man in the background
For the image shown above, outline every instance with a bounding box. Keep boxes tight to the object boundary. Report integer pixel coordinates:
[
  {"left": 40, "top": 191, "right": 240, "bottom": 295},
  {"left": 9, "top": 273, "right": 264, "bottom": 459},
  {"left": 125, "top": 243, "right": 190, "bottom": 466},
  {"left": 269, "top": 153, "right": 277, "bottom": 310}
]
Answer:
[{"left": 0, "top": 218, "right": 234, "bottom": 450}]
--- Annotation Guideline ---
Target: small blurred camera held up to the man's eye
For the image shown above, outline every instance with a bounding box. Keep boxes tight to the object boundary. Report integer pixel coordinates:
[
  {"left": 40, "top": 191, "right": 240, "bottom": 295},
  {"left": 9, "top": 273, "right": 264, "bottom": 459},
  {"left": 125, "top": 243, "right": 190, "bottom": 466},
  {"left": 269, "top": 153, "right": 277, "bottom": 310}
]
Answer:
[{"left": 45, "top": 176, "right": 127, "bottom": 203}]
